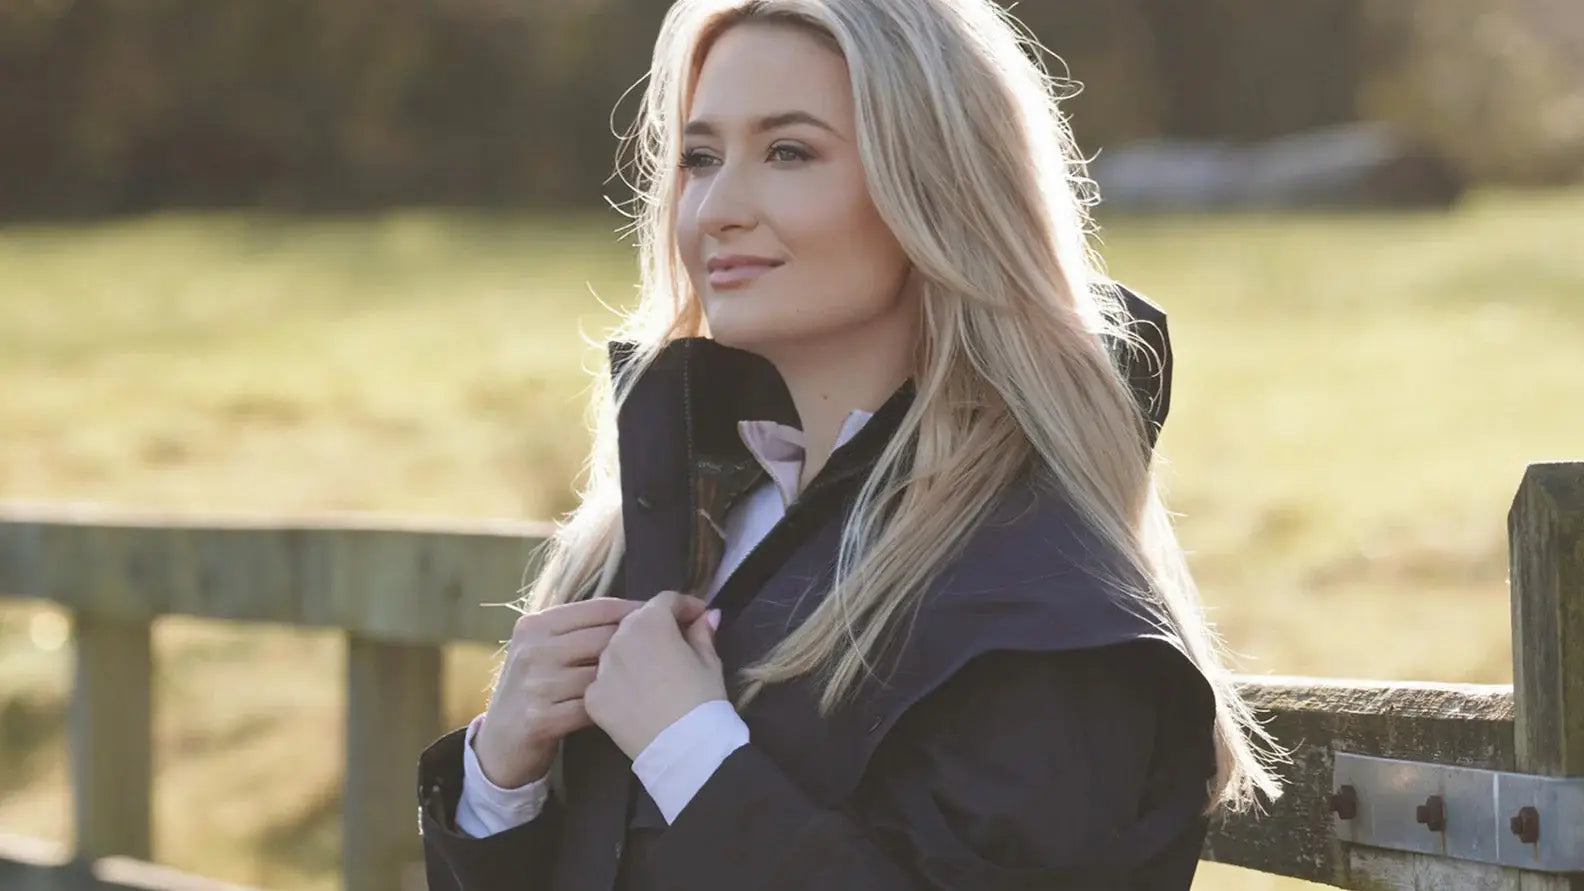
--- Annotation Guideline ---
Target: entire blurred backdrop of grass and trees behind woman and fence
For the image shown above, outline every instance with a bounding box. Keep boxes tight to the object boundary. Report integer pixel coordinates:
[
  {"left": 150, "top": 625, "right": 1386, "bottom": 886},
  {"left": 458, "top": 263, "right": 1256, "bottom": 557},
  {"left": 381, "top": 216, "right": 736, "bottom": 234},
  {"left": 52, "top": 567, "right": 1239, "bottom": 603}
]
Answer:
[{"left": 0, "top": 0, "right": 1584, "bottom": 891}]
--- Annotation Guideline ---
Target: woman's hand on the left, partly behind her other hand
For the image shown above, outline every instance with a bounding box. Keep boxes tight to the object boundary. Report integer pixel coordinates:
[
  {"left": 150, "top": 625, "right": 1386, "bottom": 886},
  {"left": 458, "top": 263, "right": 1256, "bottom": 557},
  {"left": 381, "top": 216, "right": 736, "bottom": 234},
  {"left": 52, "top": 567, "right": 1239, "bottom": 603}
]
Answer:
[{"left": 474, "top": 598, "right": 643, "bottom": 790}]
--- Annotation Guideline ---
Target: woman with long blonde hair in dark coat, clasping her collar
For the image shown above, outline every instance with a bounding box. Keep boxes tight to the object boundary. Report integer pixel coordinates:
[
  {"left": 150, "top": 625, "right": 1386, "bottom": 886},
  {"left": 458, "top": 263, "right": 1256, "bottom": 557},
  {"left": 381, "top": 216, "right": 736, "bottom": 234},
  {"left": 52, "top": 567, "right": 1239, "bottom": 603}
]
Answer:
[{"left": 418, "top": 0, "right": 1277, "bottom": 891}]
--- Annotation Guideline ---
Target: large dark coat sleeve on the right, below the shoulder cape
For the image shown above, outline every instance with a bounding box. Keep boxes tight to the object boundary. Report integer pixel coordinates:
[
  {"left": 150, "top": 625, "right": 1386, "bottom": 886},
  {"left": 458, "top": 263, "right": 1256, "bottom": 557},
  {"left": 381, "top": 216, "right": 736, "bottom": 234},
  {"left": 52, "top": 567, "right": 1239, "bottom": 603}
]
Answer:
[{"left": 654, "top": 642, "right": 1213, "bottom": 891}]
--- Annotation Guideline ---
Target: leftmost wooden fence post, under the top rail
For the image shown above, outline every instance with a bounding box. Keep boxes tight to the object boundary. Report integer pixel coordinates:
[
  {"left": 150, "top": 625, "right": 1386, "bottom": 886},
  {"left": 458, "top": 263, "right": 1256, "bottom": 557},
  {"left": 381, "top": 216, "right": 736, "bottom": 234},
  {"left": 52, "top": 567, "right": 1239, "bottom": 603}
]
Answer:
[{"left": 67, "top": 610, "right": 154, "bottom": 859}]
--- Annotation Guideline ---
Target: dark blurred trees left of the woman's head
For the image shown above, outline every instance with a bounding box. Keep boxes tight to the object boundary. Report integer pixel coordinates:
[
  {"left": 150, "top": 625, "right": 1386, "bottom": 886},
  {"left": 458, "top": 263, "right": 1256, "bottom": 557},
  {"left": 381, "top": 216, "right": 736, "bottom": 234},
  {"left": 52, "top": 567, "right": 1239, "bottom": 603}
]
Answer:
[{"left": 0, "top": 0, "right": 665, "bottom": 216}]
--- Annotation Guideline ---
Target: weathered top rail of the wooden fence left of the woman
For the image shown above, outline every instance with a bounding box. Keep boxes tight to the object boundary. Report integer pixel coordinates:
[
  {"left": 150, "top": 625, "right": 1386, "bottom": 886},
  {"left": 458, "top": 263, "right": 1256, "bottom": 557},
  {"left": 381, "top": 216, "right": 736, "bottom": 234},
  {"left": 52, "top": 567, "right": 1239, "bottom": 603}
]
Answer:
[{"left": 0, "top": 504, "right": 551, "bottom": 644}]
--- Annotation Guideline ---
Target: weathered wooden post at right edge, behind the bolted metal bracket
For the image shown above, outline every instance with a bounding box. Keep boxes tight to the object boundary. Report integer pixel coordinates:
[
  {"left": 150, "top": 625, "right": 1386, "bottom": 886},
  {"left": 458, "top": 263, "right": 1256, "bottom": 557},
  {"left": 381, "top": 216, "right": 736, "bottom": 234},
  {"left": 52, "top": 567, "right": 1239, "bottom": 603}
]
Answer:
[{"left": 1508, "top": 463, "right": 1584, "bottom": 891}]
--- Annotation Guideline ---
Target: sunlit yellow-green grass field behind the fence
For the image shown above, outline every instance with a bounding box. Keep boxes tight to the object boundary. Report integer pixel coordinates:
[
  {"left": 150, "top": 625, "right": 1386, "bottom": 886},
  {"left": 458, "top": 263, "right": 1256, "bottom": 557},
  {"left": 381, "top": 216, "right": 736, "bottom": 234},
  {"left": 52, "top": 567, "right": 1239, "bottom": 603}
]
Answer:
[{"left": 0, "top": 190, "right": 1584, "bottom": 891}]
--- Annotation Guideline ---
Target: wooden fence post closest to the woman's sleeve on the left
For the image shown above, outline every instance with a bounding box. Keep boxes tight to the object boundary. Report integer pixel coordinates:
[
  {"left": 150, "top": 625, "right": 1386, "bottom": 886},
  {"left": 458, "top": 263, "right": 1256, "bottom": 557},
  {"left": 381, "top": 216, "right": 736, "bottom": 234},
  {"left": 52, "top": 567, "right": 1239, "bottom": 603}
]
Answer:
[{"left": 341, "top": 634, "right": 442, "bottom": 891}]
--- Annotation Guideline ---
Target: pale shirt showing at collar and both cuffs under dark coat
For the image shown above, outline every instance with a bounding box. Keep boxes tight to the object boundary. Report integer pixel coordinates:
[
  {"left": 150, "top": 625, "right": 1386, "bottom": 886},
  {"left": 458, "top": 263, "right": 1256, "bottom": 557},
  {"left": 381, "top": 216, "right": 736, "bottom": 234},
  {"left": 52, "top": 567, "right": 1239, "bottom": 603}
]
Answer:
[{"left": 456, "top": 409, "right": 873, "bottom": 839}]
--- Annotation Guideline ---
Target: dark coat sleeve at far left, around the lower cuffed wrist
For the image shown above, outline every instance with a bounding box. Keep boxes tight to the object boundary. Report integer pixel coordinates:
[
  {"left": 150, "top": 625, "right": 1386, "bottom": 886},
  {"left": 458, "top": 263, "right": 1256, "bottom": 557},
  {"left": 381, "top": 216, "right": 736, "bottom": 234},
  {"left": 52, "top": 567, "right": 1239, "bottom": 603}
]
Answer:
[{"left": 418, "top": 728, "right": 561, "bottom": 891}]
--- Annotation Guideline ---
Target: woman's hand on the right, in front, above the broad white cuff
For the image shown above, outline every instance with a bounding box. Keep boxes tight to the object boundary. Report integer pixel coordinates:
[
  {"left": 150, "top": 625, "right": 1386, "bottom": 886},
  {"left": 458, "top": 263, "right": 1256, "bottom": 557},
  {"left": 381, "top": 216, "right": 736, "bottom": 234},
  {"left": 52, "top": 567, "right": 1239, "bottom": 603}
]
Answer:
[{"left": 583, "top": 591, "right": 727, "bottom": 758}]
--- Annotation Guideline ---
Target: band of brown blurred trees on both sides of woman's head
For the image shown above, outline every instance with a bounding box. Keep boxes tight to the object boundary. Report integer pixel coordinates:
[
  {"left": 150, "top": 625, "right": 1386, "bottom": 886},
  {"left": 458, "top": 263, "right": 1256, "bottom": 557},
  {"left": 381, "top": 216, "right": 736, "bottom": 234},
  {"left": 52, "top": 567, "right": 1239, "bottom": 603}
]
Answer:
[{"left": 0, "top": 0, "right": 1584, "bottom": 217}]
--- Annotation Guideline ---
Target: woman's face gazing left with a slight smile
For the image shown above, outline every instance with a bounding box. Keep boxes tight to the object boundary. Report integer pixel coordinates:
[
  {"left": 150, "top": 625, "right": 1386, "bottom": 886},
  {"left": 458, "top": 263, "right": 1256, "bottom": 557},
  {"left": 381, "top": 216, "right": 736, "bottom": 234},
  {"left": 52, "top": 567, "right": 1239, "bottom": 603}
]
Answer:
[{"left": 676, "top": 24, "right": 908, "bottom": 358}]
